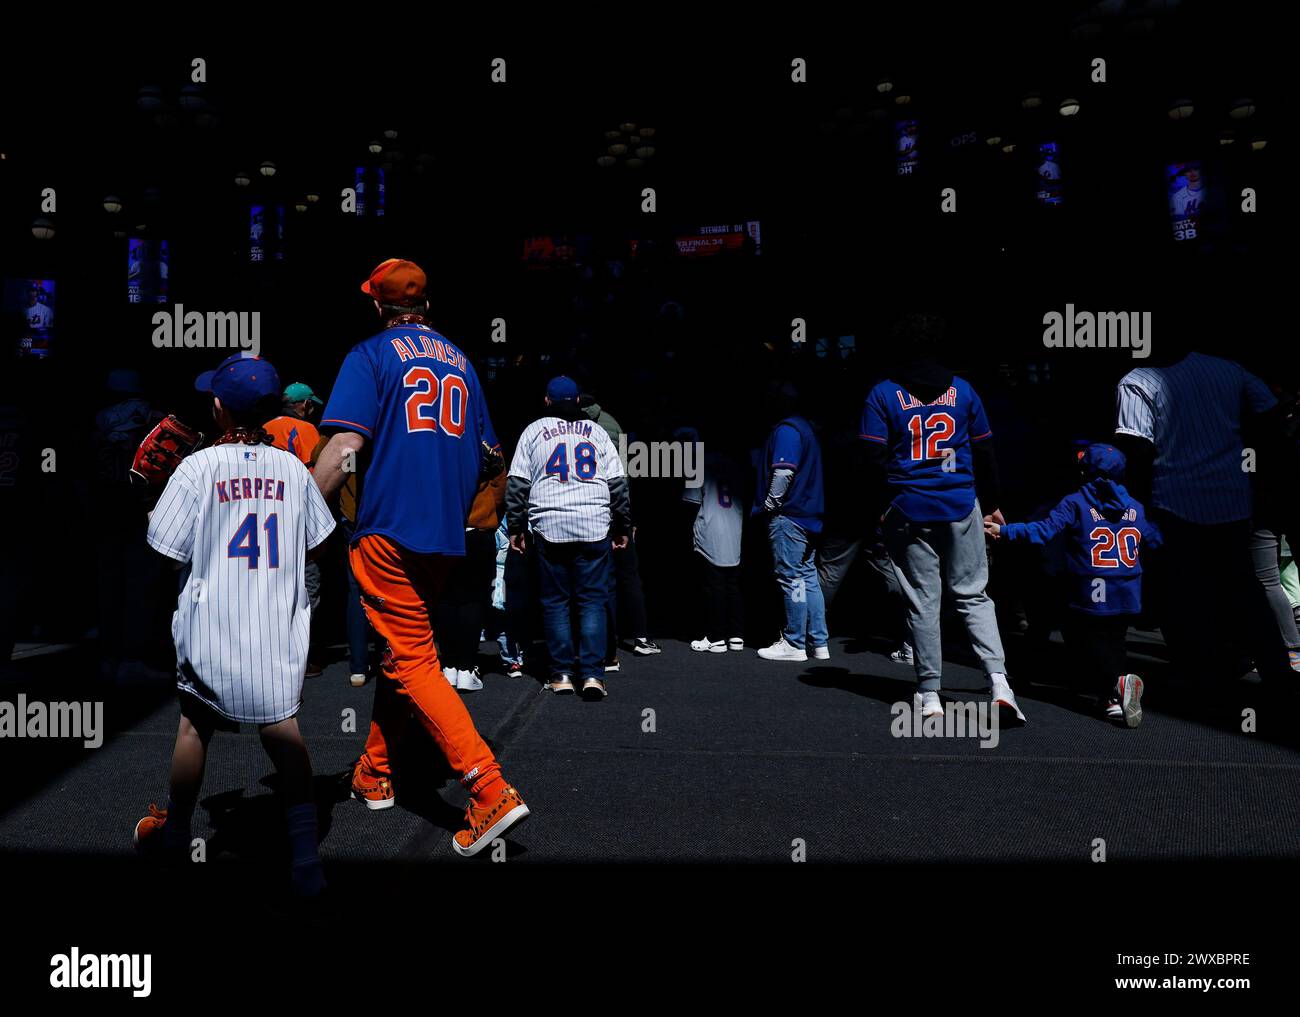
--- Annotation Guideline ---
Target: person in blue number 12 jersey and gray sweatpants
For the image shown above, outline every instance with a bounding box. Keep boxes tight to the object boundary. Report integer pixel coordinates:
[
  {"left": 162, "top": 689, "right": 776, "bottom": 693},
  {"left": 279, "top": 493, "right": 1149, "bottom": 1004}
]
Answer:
[{"left": 862, "top": 313, "right": 1024, "bottom": 722}]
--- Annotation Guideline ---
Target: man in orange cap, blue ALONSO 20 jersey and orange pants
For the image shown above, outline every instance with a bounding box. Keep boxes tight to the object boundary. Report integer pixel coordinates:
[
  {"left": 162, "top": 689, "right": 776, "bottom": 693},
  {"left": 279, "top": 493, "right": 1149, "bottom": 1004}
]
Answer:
[{"left": 316, "top": 259, "right": 528, "bottom": 856}]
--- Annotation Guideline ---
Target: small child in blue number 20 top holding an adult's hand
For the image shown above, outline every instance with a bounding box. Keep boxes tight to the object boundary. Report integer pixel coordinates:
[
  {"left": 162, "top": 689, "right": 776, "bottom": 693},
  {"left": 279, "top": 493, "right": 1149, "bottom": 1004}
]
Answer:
[{"left": 984, "top": 445, "right": 1160, "bottom": 727}]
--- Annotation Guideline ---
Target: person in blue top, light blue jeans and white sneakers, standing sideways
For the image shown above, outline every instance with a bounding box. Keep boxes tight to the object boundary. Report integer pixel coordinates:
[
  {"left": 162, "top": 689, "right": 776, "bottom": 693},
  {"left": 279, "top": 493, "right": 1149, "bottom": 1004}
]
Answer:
[{"left": 751, "top": 386, "right": 831, "bottom": 661}]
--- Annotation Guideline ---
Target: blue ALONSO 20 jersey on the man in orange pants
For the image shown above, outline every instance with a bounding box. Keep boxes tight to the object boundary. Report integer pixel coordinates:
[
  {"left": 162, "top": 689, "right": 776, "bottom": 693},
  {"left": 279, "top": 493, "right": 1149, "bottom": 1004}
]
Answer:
[{"left": 320, "top": 324, "right": 498, "bottom": 555}]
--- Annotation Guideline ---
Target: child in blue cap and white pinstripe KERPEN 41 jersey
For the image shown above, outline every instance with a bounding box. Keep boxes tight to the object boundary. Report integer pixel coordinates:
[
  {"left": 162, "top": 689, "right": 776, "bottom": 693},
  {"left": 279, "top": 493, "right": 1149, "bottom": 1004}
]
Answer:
[{"left": 135, "top": 354, "right": 334, "bottom": 897}]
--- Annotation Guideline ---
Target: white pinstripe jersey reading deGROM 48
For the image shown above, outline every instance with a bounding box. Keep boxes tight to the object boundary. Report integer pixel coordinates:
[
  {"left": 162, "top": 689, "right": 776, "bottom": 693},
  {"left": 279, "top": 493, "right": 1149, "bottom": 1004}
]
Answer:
[{"left": 510, "top": 416, "right": 625, "bottom": 544}]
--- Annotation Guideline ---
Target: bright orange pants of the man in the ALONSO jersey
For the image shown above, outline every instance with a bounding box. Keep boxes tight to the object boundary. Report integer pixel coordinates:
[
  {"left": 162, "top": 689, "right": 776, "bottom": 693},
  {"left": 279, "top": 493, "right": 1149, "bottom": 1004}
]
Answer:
[{"left": 348, "top": 535, "right": 501, "bottom": 795}]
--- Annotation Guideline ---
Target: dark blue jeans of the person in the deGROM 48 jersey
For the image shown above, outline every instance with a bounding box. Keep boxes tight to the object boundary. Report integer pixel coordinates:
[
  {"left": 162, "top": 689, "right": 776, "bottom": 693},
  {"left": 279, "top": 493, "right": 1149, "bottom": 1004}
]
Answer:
[{"left": 543, "top": 533, "right": 610, "bottom": 679}]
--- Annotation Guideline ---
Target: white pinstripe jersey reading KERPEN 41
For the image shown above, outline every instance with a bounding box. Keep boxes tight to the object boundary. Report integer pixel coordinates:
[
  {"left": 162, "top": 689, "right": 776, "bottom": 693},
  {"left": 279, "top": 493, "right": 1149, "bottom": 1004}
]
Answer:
[{"left": 148, "top": 443, "right": 334, "bottom": 724}]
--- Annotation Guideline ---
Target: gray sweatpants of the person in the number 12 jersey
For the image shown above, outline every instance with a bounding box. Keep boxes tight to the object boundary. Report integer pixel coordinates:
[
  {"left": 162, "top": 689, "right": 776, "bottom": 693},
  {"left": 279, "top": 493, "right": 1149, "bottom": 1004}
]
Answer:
[{"left": 884, "top": 502, "right": 1006, "bottom": 692}]
